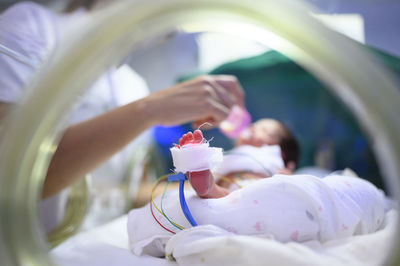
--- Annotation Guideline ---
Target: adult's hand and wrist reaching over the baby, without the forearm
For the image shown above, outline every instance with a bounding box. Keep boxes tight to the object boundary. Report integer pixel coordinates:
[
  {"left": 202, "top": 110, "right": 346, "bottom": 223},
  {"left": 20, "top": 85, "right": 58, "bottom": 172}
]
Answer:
[{"left": 146, "top": 75, "right": 244, "bottom": 126}]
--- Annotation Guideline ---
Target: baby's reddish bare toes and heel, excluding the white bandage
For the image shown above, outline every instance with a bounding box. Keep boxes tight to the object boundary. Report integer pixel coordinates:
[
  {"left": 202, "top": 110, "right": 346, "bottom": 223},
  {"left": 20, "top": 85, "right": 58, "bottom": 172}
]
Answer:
[{"left": 175, "top": 129, "right": 229, "bottom": 198}]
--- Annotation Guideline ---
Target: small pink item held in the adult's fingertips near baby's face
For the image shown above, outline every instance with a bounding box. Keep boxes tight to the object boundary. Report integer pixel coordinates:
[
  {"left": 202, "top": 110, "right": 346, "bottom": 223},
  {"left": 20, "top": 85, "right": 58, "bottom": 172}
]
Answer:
[{"left": 219, "top": 105, "right": 251, "bottom": 139}]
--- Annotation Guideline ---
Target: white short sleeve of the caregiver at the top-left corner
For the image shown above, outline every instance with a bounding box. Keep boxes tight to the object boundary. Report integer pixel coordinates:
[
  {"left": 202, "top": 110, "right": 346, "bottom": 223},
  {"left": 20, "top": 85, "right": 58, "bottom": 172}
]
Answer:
[{"left": 0, "top": 2, "right": 57, "bottom": 102}]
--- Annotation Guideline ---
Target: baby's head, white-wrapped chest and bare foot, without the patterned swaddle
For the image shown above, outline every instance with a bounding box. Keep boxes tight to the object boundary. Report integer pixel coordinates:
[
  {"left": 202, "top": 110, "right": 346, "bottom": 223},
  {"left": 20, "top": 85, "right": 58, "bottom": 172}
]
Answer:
[{"left": 181, "top": 119, "right": 299, "bottom": 198}]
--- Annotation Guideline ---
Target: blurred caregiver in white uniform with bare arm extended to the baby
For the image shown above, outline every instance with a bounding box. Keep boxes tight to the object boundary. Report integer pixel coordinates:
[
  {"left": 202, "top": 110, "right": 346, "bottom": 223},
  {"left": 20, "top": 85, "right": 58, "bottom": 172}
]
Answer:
[{"left": 0, "top": 1, "right": 243, "bottom": 233}]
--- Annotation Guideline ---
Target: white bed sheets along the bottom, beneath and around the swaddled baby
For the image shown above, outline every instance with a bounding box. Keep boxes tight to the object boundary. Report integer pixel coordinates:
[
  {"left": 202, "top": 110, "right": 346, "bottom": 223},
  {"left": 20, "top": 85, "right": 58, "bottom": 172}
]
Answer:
[{"left": 50, "top": 210, "right": 397, "bottom": 266}]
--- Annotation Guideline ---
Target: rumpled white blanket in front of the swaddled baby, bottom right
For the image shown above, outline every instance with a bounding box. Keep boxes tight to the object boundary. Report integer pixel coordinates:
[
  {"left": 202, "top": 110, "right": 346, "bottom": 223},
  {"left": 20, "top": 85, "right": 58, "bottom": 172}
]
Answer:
[{"left": 166, "top": 210, "right": 397, "bottom": 266}]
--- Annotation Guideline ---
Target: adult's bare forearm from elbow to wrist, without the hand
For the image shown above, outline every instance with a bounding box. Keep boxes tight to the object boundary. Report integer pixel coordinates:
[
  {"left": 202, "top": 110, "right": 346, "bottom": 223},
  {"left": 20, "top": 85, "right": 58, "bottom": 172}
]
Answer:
[{"left": 42, "top": 99, "right": 156, "bottom": 197}]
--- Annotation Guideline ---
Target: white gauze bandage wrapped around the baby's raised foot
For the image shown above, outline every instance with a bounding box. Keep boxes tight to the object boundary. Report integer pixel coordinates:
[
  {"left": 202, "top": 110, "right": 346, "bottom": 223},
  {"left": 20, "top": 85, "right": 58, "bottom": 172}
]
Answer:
[{"left": 170, "top": 143, "right": 223, "bottom": 173}]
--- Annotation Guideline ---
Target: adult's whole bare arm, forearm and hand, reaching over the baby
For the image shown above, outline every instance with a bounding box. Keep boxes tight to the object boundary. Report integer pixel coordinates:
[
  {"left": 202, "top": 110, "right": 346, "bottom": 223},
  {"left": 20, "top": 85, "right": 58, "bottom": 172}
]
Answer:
[{"left": 42, "top": 76, "right": 243, "bottom": 197}]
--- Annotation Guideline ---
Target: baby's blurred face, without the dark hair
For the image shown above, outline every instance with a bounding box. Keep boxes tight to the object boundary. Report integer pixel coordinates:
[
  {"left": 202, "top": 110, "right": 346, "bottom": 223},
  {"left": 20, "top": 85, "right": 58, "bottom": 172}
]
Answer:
[{"left": 236, "top": 119, "right": 286, "bottom": 147}]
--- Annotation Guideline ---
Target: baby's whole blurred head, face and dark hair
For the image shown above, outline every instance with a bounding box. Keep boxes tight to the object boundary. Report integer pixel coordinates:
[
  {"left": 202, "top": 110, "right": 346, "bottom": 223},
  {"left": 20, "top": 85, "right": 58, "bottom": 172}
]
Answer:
[{"left": 236, "top": 119, "right": 300, "bottom": 165}]
